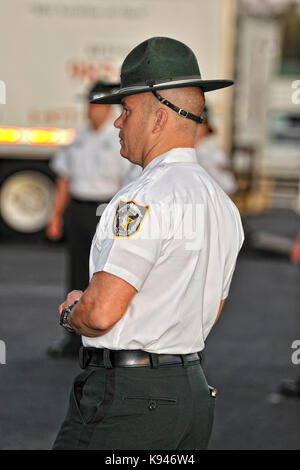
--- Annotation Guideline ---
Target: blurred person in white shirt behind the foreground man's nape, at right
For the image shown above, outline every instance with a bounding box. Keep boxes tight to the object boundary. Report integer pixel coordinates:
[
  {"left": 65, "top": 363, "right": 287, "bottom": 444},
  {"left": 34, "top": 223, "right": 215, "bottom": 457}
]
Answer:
[{"left": 195, "top": 106, "right": 236, "bottom": 195}]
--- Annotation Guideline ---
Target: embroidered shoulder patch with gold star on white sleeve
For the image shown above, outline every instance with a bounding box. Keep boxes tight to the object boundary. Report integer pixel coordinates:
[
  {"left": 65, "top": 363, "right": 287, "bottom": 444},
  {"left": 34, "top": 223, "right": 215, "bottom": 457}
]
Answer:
[{"left": 113, "top": 199, "right": 149, "bottom": 237}]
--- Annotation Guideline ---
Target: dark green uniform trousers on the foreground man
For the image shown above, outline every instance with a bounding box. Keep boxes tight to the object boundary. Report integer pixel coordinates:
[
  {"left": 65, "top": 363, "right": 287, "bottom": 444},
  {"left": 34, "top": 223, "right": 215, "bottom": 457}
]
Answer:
[{"left": 53, "top": 363, "right": 215, "bottom": 450}]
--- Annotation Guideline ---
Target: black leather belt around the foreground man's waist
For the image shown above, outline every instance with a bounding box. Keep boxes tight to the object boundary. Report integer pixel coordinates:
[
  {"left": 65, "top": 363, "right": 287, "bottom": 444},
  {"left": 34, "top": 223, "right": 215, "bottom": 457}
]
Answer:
[{"left": 79, "top": 346, "right": 201, "bottom": 369}]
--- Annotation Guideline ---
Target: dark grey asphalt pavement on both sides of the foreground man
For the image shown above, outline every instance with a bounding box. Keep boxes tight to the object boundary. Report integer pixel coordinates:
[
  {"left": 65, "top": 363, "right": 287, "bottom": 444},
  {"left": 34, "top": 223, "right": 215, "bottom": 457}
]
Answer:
[{"left": 0, "top": 211, "right": 300, "bottom": 450}]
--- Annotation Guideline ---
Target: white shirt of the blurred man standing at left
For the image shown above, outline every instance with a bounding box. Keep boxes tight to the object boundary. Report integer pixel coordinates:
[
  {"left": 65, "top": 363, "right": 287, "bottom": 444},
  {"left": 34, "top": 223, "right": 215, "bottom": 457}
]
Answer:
[{"left": 50, "top": 121, "right": 133, "bottom": 201}]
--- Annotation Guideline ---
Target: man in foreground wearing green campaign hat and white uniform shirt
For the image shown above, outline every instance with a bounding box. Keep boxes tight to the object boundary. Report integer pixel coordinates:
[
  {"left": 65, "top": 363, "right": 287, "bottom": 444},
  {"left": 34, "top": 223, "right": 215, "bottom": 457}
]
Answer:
[{"left": 54, "top": 37, "right": 243, "bottom": 450}]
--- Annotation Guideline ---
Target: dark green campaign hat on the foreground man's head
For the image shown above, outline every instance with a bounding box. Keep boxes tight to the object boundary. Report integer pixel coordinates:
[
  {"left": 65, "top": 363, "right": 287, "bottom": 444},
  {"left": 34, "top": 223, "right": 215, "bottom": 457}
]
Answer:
[{"left": 91, "top": 37, "right": 233, "bottom": 104}]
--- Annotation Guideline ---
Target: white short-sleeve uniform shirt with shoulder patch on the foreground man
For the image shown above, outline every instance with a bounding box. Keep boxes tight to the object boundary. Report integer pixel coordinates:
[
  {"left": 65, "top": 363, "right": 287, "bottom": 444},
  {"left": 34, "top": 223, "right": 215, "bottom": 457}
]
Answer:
[{"left": 83, "top": 148, "right": 243, "bottom": 354}]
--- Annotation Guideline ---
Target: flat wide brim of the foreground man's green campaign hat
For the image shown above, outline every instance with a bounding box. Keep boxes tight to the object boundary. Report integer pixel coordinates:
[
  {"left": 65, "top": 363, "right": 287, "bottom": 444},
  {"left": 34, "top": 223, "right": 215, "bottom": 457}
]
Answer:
[{"left": 90, "top": 78, "right": 234, "bottom": 104}]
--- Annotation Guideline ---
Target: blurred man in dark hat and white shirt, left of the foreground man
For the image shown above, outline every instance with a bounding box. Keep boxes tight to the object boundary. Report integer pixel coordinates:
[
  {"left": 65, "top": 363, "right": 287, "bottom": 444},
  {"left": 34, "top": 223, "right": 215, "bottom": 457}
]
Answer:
[{"left": 46, "top": 81, "right": 133, "bottom": 357}]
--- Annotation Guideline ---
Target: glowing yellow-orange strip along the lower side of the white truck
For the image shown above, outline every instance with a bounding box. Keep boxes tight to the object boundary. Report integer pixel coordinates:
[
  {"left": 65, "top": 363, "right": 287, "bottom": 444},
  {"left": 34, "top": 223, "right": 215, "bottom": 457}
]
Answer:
[{"left": 0, "top": 126, "right": 75, "bottom": 145}]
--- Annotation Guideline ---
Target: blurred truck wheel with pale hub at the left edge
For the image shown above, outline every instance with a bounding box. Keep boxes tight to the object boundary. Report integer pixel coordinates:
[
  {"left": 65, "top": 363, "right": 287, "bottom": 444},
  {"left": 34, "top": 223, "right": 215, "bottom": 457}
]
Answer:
[{"left": 0, "top": 161, "right": 54, "bottom": 239}]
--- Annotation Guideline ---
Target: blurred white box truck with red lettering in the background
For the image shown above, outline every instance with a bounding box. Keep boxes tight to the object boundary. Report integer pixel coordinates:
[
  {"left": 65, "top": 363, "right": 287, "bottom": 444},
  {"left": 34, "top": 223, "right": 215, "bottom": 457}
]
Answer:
[{"left": 0, "top": 0, "right": 235, "bottom": 236}]
